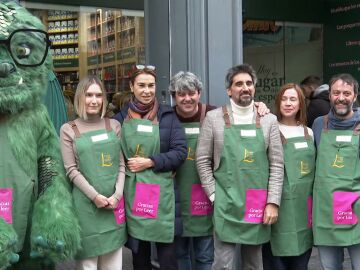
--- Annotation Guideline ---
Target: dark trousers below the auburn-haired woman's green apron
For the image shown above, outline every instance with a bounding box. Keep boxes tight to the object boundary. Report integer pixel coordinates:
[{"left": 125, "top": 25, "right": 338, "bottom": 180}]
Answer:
[{"left": 262, "top": 243, "right": 312, "bottom": 270}]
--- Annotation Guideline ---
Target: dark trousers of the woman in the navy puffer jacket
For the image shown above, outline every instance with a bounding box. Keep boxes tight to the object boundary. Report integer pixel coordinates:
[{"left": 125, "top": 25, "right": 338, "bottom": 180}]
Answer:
[{"left": 132, "top": 240, "right": 178, "bottom": 270}]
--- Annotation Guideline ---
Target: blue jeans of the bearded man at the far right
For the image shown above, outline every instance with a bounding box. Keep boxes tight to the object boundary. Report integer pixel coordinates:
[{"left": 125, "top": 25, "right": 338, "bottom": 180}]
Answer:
[{"left": 318, "top": 244, "right": 360, "bottom": 270}]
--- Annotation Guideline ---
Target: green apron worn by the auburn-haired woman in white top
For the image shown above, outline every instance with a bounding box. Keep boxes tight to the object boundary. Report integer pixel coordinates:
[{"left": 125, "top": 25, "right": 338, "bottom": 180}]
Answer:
[{"left": 270, "top": 128, "right": 315, "bottom": 256}]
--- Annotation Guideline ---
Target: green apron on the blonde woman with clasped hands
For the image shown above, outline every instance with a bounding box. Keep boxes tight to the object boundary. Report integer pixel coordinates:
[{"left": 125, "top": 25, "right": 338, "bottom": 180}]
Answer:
[{"left": 69, "top": 118, "right": 127, "bottom": 259}]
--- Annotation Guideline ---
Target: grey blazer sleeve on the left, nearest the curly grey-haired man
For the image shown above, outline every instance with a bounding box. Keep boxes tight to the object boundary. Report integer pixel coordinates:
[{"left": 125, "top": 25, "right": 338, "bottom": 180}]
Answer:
[{"left": 196, "top": 114, "right": 215, "bottom": 198}]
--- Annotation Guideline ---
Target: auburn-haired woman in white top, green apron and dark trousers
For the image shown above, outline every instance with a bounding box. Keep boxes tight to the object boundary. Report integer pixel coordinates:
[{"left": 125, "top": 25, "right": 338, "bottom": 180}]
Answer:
[{"left": 263, "top": 83, "right": 315, "bottom": 270}]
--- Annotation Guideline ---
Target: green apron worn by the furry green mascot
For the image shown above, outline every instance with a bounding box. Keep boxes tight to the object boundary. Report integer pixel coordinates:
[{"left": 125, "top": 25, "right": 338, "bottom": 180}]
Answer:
[{"left": 0, "top": 122, "right": 38, "bottom": 252}]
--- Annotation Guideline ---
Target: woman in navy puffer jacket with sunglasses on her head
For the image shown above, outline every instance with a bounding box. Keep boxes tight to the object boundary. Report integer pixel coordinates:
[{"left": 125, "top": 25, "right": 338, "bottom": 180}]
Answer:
[{"left": 115, "top": 65, "right": 187, "bottom": 270}]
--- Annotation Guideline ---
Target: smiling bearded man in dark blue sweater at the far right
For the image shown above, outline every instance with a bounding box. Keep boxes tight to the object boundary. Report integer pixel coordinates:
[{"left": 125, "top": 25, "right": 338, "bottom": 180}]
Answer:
[{"left": 313, "top": 74, "right": 360, "bottom": 270}]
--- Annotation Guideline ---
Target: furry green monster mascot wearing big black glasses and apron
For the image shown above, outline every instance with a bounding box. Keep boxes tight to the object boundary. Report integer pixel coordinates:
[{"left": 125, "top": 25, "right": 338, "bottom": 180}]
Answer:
[{"left": 0, "top": 0, "right": 80, "bottom": 270}]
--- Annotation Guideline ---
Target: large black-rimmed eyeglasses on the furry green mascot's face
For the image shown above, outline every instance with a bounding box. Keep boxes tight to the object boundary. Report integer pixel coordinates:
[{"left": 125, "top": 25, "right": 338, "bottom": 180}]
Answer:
[{"left": 0, "top": 29, "right": 51, "bottom": 67}]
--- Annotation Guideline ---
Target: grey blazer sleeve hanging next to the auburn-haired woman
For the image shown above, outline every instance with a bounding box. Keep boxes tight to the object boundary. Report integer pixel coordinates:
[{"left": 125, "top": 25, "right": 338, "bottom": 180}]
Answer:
[{"left": 267, "top": 117, "right": 284, "bottom": 206}]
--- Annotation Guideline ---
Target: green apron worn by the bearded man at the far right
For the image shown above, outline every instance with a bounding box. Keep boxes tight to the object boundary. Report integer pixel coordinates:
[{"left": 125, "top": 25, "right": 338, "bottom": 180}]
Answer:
[{"left": 313, "top": 116, "right": 360, "bottom": 246}]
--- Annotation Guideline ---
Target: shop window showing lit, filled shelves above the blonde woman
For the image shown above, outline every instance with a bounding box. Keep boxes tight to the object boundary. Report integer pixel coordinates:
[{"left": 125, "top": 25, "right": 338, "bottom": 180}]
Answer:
[{"left": 22, "top": 1, "right": 145, "bottom": 101}]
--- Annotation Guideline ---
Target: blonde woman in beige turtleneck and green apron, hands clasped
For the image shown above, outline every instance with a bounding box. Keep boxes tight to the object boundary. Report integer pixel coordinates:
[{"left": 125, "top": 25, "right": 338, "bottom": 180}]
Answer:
[{"left": 60, "top": 76, "right": 127, "bottom": 270}]
